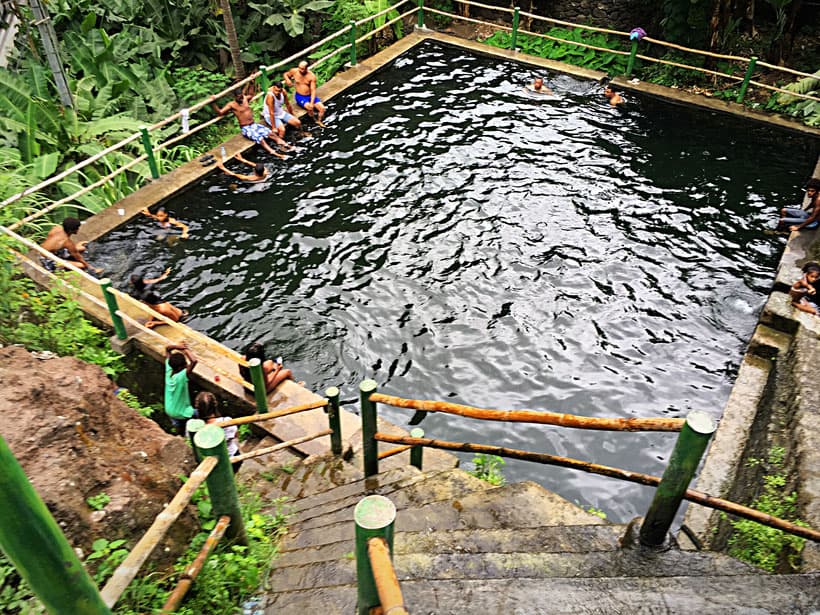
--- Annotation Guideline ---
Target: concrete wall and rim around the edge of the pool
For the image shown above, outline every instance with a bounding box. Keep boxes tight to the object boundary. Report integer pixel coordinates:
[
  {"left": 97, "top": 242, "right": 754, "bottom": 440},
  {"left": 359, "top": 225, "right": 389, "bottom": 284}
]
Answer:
[{"left": 46, "top": 30, "right": 820, "bottom": 556}]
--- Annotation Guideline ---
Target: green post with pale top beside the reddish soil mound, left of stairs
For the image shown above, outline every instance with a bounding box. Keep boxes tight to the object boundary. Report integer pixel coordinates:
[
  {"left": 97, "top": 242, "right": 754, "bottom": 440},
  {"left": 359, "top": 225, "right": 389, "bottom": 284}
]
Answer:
[{"left": 194, "top": 423, "right": 248, "bottom": 545}]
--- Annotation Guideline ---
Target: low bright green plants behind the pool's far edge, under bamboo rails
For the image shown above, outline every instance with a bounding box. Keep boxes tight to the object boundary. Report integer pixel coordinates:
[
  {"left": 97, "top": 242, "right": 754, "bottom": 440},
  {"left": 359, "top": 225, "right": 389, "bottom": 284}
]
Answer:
[{"left": 484, "top": 28, "right": 628, "bottom": 75}]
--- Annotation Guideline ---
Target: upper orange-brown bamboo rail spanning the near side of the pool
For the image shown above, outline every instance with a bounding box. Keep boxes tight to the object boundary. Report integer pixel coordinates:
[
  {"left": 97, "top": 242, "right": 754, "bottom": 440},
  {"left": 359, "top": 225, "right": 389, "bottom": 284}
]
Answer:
[{"left": 370, "top": 393, "right": 684, "bottom": 431}]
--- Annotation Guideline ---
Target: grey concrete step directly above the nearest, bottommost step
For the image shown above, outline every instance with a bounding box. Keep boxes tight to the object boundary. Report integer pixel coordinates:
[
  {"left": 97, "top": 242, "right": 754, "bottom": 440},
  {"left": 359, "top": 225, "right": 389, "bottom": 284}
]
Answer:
[{"left": 269, "top": 549, "right": 753, "bottom": 592}]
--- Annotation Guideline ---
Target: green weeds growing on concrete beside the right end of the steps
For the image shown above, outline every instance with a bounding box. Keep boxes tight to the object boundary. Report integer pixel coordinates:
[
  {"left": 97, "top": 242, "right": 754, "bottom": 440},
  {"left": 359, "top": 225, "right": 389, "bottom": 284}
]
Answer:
[{"left": 729, "top": 447, "right": 806, "bottom": 572}]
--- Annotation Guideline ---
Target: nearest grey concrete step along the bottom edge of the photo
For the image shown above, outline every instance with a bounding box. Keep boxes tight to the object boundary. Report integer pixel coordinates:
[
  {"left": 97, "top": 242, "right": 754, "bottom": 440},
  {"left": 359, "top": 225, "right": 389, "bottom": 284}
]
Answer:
[{"left": 264, "top": 574, "right": 820, "bottom": 615}]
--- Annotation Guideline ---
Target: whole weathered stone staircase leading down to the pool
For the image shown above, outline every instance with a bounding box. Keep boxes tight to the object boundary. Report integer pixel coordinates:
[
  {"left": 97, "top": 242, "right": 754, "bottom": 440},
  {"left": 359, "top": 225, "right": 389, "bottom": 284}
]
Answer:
[{"left": 234, "top": 441, "right": 820, "bottom": 615}]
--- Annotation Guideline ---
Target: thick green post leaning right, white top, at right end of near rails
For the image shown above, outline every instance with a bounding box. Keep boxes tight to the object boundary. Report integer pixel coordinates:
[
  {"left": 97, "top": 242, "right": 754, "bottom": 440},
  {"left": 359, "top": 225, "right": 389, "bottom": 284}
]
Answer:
[{"left": 640, "top": 410, "right": 717, "bottom": 548}]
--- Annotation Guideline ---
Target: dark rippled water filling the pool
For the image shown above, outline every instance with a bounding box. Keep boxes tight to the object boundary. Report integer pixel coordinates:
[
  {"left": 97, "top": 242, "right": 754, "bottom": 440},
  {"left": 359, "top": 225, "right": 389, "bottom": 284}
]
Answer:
[{"left": 93, "top": 44, "right": 817, "bottom": 520}]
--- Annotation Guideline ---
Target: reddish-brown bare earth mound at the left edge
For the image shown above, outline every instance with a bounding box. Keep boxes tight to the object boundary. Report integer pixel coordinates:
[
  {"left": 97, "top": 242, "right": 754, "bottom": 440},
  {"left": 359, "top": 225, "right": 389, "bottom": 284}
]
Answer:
[{"left": 0, "top": 346, "right": 196, "bottom": 559}]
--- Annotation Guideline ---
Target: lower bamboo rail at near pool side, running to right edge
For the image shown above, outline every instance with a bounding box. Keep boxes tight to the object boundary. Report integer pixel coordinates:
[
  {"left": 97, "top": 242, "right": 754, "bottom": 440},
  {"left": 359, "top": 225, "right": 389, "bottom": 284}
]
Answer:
[{"left": 374, "top": 432, "right": 820, "bottom": 542}]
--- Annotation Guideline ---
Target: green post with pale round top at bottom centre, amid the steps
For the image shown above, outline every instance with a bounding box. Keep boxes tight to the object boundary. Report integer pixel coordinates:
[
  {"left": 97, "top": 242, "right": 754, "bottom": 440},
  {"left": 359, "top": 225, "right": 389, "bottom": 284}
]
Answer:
[{"left": 353, "top": 495, "right": 396, "bottom": 615}]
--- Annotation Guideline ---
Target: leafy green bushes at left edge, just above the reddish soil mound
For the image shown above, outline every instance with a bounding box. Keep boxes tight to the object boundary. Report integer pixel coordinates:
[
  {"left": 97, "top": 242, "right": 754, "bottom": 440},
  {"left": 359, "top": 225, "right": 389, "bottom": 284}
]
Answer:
[{"left": 0, "top": 238, "right": 125, "bottom": 376}]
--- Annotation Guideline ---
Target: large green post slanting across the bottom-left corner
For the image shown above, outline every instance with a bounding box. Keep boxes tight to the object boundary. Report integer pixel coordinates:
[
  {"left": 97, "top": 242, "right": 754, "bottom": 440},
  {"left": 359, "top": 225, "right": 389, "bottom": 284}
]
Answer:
[{"left": 0, "top": 437, "right": 111, "bottom": 615}]
